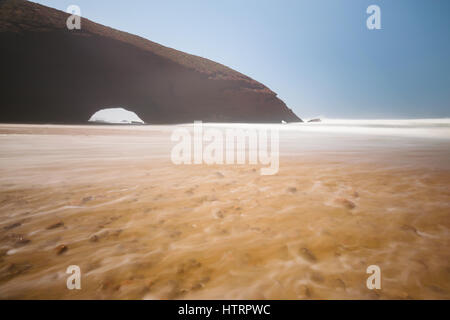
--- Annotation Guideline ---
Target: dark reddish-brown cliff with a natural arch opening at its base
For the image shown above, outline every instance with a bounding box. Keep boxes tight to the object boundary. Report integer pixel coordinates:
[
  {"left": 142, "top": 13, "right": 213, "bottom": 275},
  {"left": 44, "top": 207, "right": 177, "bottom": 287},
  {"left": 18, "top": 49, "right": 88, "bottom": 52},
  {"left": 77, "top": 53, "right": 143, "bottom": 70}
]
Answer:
[{"left": 0, "top": 0, "right": 301, "bottom": 123}]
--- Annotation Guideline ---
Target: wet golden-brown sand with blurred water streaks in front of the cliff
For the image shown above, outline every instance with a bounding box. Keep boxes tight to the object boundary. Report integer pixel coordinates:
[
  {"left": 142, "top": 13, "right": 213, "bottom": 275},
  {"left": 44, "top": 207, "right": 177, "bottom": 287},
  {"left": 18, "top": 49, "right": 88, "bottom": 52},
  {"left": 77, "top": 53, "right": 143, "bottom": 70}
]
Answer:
[{"left": 0, "top": 125, "right": 450, "bottom": 299}]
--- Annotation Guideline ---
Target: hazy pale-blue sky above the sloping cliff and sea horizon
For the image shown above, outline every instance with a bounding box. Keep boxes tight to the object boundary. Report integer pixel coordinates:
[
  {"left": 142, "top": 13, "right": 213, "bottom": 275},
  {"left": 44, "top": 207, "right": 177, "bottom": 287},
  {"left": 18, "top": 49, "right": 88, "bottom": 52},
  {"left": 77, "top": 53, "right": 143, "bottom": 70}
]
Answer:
[{"left": 31, "top": 0, "right": 450, "bottom": 118}]
